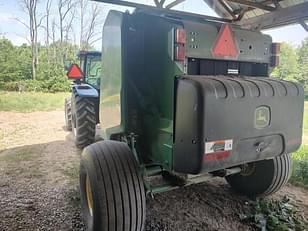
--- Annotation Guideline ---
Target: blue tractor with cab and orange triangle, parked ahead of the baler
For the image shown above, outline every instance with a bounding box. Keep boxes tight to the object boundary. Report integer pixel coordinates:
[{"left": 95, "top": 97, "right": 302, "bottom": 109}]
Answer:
[{"left": 64, "top": 51, "right": 102, "bottom": 148}]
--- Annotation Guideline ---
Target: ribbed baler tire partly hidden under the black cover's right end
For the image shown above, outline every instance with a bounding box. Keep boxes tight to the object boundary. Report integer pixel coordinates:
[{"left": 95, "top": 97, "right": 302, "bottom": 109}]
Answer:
[{"left": 226, "top": 154, "right": 292, "bottom": 197}]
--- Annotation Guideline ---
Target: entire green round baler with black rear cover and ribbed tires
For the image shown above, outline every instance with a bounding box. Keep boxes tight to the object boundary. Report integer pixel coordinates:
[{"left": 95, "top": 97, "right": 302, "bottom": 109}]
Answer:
[{"left": 72, "top": 0, "right": 304, "bottom": 231}]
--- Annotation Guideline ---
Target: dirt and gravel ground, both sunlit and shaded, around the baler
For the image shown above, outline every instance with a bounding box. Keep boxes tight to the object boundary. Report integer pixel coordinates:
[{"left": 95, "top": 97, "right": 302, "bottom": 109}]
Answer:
[{"left": 0, "top": 111, "right": 308, "bottom": 231}]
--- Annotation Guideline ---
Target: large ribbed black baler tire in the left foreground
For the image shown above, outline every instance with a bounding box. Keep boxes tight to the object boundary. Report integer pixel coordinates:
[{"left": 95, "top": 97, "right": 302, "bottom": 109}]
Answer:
[{"left": 80, "top": 140, "right": 146, "bottom": 231}]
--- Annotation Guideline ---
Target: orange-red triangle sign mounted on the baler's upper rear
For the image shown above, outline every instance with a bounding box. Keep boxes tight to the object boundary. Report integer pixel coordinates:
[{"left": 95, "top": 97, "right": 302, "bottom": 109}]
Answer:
[{"left": 212, "top": 24, "right": 239, "bottom": 59}]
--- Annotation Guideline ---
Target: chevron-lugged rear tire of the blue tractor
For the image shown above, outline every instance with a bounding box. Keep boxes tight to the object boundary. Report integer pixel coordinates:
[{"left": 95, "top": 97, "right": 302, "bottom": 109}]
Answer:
[{"left": 72, "top": 94, "right": 96, "bottom": 148}]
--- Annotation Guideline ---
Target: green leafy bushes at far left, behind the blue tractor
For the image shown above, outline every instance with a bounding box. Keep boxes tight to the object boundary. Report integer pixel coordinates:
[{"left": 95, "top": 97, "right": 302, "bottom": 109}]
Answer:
[{"left": 0, "top": 38, "right": 77, "bottom": 92}]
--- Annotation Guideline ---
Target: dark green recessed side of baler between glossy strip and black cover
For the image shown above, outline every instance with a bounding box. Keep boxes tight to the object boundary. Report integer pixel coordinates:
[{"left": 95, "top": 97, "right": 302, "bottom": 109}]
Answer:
[{"left": 123, "top": 13, "right": 182, "bottom": 170}]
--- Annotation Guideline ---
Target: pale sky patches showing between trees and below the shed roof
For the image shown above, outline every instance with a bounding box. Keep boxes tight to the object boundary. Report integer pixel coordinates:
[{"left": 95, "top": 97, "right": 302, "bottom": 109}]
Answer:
[{"left": 0, "top": 0, "right": 308, "bottom": 49}]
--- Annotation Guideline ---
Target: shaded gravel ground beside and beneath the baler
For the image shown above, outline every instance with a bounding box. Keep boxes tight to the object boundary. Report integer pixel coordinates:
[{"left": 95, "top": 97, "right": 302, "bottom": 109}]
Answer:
[{"left": 0, "top": 139, "right": 254, "bottom": 231}]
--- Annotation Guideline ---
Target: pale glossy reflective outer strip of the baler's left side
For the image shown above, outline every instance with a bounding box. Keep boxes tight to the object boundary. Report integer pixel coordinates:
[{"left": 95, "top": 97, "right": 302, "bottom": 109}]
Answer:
[{"left": 99, "top": 11, "right": 125, "bottom": 139}]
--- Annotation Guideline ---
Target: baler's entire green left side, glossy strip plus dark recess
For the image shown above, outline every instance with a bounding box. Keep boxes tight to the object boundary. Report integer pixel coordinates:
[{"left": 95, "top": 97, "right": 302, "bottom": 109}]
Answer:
[{"left": 100, "top": 12, "right": 183, "bottom": 169}]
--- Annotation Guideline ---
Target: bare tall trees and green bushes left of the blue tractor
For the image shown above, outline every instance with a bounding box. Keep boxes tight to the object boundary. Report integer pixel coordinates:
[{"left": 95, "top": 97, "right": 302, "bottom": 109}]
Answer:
[{"left": 0, "top": 0, "right": 104, "bottom": 91}]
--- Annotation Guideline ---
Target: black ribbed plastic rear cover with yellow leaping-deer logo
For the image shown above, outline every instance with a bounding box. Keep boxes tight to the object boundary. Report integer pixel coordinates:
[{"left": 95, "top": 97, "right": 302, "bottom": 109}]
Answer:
[{"left": 174, "top": 76, "right": 304, "bottom": 173}]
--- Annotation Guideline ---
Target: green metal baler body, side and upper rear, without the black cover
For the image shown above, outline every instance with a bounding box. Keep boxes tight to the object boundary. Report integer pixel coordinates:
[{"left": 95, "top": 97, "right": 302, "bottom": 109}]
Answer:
[{"left": 100, "top": 11, "right": 304, "bottom": 173}]
